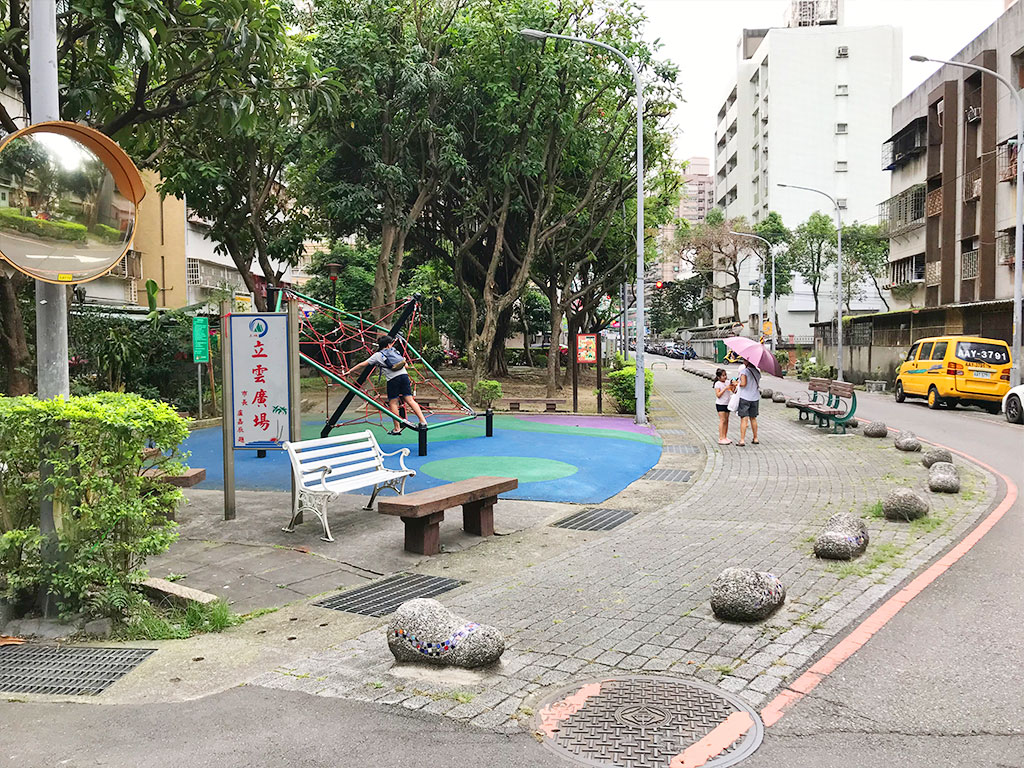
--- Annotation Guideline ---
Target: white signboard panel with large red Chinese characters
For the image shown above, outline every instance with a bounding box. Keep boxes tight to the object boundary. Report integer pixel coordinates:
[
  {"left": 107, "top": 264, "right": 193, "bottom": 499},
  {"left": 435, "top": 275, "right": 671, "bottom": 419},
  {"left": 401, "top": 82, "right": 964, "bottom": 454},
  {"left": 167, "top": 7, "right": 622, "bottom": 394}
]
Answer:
[{"left": 227, "top": 312, "right": 298, "bottom": 451}]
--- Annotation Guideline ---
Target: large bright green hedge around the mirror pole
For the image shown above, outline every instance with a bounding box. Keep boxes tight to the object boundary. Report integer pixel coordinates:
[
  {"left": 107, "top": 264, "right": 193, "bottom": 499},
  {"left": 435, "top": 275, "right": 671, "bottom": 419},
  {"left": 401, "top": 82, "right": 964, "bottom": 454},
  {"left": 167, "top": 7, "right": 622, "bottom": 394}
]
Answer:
[{"left": 0, "top": 392, "right": 187, "bottom": 615}]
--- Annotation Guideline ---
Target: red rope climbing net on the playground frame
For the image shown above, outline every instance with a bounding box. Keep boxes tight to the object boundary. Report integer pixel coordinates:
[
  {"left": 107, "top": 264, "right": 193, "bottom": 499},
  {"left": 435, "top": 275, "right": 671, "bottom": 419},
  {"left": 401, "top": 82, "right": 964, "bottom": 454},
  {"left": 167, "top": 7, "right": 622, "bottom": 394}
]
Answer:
[{"left": 295, "top": 294, "right": 472, "bottom": 427}]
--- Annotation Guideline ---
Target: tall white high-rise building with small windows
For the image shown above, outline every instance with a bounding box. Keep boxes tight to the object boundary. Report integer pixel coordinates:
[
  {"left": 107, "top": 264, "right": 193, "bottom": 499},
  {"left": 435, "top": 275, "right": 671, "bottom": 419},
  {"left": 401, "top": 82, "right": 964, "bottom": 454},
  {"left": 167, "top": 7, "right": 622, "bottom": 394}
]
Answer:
[{"left": 714, "top": 0, "right": 903, "bottom": 336}]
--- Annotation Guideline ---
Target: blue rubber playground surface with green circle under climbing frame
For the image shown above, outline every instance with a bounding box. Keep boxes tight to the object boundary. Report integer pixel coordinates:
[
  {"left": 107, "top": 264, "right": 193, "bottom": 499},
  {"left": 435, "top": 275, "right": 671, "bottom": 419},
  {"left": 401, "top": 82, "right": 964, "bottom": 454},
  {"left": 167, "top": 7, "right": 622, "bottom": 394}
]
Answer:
[{"left": 183, "top": 414, "right": 662, "bottom": 504}]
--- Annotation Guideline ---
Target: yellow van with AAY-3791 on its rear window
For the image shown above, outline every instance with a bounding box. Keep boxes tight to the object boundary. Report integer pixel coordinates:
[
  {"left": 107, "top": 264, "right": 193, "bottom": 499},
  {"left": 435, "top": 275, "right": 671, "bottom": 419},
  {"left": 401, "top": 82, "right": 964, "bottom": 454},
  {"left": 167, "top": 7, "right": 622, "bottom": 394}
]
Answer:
[{"left": 896, "top": 336, "right": 1010, "bottom": 414}]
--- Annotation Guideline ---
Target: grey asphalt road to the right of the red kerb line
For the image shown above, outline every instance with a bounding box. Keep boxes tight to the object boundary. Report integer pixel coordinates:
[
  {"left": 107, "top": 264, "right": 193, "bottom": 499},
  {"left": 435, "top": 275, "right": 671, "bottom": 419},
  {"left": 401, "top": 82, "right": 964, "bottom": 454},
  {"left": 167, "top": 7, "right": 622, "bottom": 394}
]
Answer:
[{"left": 688, "top": 358, "right": 1024, "bottom": 768}]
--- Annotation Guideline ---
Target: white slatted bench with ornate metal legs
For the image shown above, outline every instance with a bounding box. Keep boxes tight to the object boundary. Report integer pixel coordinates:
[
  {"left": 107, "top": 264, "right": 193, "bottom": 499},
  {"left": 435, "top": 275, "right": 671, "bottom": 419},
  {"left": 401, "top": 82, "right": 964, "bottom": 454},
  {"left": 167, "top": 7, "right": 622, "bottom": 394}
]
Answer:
[{"left": 284, "top": 429, "right": 416, "bottom": 542}]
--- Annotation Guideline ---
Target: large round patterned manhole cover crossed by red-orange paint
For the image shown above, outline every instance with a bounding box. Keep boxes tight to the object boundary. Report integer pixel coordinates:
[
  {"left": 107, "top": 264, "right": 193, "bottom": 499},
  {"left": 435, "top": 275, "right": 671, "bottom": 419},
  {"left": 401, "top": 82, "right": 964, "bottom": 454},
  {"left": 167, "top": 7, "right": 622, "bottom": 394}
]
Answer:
[{"left": 537, "top": 677, "right": 764, "bottom": 768}]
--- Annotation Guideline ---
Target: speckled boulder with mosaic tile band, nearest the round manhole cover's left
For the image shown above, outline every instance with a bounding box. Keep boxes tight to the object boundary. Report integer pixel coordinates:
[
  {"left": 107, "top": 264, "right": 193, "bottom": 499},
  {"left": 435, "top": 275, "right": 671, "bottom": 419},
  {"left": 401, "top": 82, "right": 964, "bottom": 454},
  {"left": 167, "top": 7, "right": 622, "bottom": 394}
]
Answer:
[{"left": 387, "top": 597, "right": 505, "bottom": 669}]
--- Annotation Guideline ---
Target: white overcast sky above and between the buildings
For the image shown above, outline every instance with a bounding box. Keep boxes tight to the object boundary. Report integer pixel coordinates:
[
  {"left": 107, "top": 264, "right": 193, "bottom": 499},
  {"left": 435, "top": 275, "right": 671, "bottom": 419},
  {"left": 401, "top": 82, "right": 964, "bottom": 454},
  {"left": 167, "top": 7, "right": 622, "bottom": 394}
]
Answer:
[{"left": 639, "top": 0, "right": 1004, "bottom": 160}]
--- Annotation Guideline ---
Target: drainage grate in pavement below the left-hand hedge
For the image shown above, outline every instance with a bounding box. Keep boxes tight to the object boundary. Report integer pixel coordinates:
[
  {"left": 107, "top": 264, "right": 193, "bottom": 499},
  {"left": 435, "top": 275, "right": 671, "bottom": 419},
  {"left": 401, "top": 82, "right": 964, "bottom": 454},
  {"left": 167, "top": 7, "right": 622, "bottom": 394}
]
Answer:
[{"left": 0, "top": 645, "right": 154, "bottom": 696}]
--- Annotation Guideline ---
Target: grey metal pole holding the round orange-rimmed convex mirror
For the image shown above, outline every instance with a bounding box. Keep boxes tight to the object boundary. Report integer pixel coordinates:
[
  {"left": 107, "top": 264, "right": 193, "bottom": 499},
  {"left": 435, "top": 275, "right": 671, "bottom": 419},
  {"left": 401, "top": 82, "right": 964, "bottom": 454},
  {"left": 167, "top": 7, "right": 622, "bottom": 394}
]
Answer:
[{"left": 29, "top": 0, "right": 62, "bottom": 616}]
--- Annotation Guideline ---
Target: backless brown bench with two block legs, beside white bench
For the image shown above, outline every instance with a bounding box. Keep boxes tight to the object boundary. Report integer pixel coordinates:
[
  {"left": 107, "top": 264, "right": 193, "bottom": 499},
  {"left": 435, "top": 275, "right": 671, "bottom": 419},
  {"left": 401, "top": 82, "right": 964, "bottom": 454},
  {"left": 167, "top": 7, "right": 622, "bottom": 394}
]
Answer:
[{"left": 377, "top": 477, "right": 519, "bottom": 555}]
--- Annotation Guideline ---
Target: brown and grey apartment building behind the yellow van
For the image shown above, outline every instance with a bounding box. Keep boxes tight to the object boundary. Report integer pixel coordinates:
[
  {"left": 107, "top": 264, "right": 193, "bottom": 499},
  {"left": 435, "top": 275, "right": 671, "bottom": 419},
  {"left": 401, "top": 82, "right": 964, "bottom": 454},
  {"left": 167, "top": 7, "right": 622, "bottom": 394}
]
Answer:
[{"left": 879, "top": 3, "right": 1024, "bottom": 341}]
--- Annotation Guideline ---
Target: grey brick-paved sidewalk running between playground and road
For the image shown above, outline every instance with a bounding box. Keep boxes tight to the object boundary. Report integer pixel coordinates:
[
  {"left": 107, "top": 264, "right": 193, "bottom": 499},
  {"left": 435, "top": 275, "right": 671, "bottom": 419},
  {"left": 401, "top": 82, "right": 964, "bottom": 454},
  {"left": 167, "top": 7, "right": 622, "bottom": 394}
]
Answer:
[{"left": 254, "top": 370, "right": 996, "bottom": 731}]
